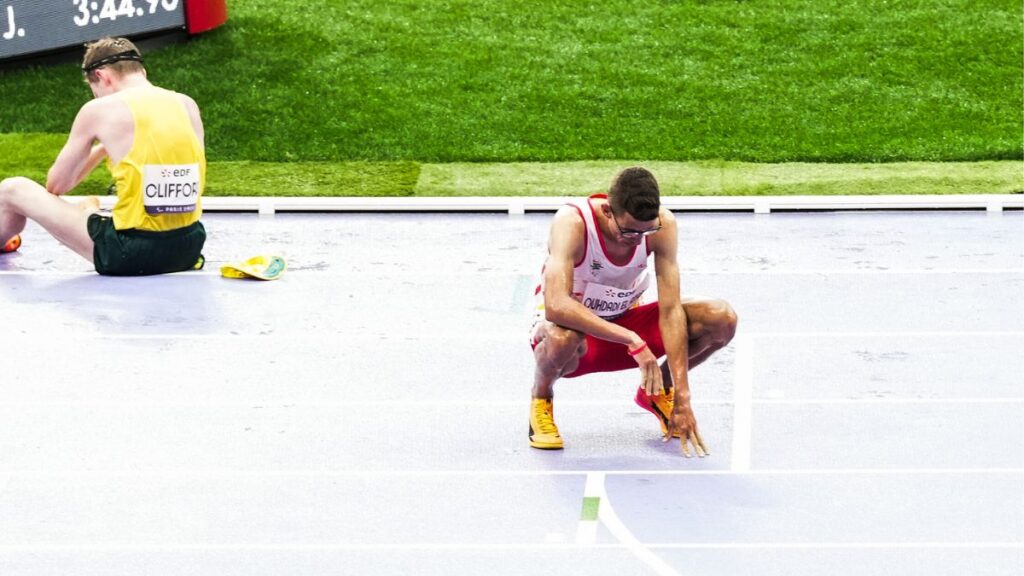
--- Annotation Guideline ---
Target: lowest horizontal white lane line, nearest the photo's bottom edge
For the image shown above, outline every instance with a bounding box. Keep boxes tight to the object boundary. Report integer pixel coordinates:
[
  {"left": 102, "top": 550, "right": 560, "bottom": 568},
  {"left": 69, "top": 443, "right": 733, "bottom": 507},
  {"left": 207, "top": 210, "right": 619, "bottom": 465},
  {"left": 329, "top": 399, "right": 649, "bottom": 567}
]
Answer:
[{"left": 0, "top": 542, "right": 1024, "bottom": 549}]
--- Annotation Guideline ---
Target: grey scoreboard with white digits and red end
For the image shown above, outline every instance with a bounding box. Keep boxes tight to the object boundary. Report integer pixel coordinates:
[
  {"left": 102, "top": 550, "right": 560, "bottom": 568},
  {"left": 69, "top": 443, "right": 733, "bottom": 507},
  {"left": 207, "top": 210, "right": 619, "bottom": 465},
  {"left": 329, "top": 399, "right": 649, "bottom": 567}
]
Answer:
[{"left": 0, "top": 0, "right": 227, "bottom": 60}]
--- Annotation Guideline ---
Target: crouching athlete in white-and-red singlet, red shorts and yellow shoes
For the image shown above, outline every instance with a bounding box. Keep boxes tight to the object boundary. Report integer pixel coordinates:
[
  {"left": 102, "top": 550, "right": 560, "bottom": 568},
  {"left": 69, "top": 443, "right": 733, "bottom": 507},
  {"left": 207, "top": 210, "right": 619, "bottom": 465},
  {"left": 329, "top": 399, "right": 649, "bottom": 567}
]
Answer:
[{"left": 529, "top": 168, "right": 736, "bottom": 457}]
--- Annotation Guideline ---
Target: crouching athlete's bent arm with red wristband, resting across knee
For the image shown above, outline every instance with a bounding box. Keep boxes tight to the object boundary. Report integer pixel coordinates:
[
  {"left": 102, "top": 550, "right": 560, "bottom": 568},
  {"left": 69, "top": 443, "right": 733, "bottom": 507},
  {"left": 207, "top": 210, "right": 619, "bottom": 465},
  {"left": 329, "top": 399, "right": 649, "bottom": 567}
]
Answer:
[{"left": 544, "top": 206, "right": 664, "bottom": 394}]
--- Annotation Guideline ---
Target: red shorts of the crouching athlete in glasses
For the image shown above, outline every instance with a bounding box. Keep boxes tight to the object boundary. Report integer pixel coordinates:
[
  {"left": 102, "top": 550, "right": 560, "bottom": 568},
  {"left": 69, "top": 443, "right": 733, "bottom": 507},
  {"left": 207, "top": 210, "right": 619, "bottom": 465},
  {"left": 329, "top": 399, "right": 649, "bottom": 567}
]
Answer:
[{"left": 532, "top": 302, "right": 665, "bottom": 378}]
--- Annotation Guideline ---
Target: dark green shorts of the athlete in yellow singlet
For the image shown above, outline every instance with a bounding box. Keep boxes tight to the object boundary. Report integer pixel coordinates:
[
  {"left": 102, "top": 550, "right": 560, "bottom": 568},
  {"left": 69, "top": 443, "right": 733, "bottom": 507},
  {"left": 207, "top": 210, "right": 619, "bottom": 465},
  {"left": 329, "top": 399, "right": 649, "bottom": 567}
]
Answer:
[{"left": 88, "top": 214, "right": 206, "bottom": 276}]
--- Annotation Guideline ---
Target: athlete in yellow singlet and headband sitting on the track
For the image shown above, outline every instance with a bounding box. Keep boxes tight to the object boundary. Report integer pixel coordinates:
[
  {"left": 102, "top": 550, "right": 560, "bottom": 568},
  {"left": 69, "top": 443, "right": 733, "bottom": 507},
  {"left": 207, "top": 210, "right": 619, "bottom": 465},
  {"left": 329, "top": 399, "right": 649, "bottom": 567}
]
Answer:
[{"left": 0, "top": 38, "right": 206, "bottom": 276}]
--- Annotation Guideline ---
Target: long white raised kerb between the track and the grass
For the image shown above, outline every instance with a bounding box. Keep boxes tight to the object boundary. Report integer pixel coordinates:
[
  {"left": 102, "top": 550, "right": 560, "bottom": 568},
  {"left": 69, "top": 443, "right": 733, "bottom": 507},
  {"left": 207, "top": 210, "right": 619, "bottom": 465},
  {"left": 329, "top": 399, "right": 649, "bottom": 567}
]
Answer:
[{"left": 100, "top": 194, "right": 1024, "bottom": 214}]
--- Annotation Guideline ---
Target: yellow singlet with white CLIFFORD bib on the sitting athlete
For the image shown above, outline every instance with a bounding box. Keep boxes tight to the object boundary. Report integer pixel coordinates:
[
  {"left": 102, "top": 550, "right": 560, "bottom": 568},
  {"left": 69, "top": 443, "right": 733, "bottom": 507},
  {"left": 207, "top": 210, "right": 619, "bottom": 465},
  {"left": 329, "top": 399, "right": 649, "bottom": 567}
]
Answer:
[{"left": 106, "top": 87, "right": 206, "bottom": 232}]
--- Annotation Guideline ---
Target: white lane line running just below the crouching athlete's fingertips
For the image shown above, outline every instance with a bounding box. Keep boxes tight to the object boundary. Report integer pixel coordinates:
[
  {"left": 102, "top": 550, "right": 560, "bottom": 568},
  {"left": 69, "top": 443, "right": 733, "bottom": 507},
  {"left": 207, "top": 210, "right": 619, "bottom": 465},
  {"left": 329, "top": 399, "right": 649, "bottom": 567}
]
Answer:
[{"left": 0, "top": 467, "right": 1024, "bottom": 479}]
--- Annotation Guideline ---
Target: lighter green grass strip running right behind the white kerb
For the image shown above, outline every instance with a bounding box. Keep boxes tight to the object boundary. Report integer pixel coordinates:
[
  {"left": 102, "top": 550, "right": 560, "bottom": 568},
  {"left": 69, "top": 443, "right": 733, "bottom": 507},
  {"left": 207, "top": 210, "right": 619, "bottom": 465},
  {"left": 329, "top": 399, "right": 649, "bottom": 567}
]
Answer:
[{"left": 0, "top": 134, "right": 1024, "bottom": 197}]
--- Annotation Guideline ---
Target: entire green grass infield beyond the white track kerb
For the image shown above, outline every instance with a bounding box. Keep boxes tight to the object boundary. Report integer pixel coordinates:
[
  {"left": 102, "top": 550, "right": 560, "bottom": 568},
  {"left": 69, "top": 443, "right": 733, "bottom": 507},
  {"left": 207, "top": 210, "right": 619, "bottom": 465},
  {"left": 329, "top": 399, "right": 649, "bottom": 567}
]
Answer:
[{"left": 0, "top": 0, "right": 1024, "bottom": 194}]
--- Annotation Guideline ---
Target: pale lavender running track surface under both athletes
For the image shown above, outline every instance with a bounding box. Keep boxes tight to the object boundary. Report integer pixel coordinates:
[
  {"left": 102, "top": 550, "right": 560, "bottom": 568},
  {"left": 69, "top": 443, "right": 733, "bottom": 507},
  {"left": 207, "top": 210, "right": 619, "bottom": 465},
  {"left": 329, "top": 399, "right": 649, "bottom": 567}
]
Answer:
[{"left": 0, "top": 212, "right": 1024, "bottom": 576}]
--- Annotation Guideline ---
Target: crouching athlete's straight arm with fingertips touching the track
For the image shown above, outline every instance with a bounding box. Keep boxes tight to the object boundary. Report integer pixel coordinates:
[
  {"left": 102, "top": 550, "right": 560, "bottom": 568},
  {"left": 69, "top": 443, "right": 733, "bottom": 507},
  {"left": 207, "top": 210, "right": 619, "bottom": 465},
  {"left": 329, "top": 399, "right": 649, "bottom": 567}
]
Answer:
[{"left": 649, "top": 208, "right": 708, "bottom": 456}]
